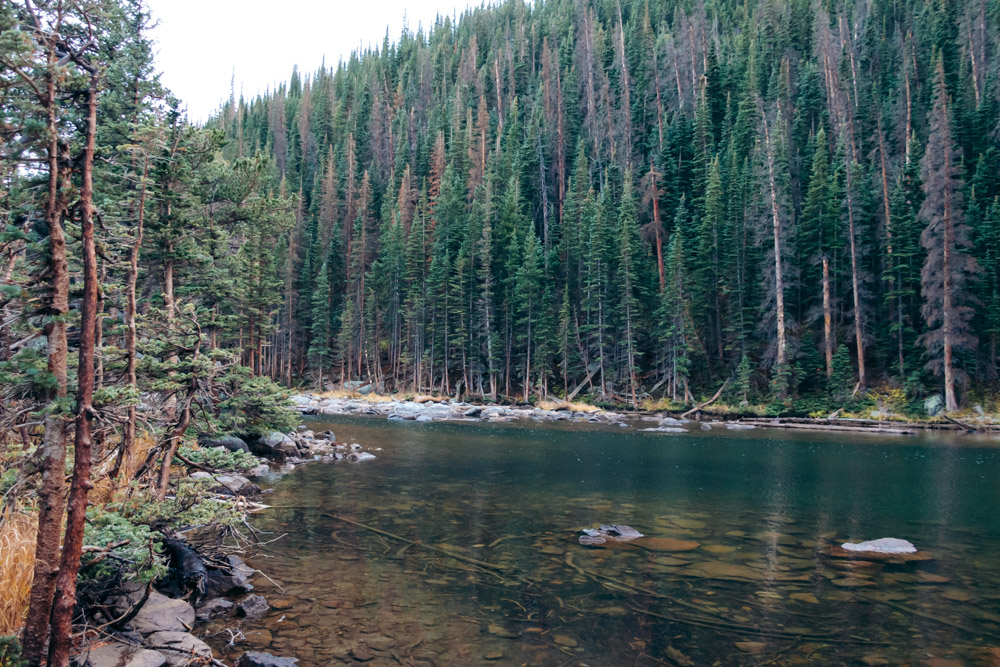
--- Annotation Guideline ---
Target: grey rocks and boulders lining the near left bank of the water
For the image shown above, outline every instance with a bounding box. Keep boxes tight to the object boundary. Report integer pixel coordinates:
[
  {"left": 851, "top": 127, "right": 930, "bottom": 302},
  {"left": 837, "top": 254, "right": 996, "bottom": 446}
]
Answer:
[{"left": 77, "top": 426, "right": 378, "bottom": 667}]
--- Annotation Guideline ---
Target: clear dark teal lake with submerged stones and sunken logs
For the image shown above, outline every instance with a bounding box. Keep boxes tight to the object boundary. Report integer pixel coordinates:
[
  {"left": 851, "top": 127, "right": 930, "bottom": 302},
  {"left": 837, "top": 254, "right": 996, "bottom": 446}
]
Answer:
[{"left": 215, "top": 417, "right": 1000, "bottom": 667}]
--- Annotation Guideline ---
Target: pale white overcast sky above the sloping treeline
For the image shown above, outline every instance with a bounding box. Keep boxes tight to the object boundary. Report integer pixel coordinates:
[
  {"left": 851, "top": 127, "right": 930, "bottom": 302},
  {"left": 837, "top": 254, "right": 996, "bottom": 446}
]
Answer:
[{"left": 147, "top": 0, "right": 480, "bottom": 121}]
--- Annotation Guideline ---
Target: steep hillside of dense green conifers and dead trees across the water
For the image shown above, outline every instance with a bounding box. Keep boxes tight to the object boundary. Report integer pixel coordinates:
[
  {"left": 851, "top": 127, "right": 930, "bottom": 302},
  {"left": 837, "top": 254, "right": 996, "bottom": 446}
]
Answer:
[{"left": 211, "top": 0, "right": 1000, "bottom": 408}]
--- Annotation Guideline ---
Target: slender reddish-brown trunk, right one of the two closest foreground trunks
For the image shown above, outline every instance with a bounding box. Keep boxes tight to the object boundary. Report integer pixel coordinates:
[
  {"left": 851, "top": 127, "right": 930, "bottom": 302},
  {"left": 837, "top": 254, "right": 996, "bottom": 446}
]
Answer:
[{"left": 48, "top": 82, "right": 98, "bottom": 667}]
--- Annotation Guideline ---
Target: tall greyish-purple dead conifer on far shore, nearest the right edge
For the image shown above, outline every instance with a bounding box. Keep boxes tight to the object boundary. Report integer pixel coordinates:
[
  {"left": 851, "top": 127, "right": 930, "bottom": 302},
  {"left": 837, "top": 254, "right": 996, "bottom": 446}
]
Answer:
[{"left": 920, "top": 61, "right": 979, "bottom": 412}]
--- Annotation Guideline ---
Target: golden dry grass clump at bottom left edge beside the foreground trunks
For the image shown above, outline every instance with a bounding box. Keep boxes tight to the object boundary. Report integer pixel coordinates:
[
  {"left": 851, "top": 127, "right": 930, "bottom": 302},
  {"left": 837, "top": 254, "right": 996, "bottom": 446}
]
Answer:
[{"left": 0, "top": 507, "right": 38, "bottom": 636}]
